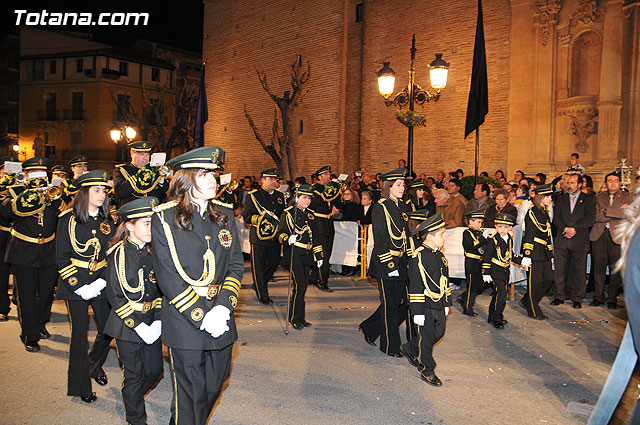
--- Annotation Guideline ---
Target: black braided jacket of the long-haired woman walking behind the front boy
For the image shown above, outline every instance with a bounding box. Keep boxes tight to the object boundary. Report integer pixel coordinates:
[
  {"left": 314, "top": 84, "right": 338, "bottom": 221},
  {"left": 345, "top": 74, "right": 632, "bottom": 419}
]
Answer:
[{"left": 369, "top": 198, "right": 412, "bottom": 281}]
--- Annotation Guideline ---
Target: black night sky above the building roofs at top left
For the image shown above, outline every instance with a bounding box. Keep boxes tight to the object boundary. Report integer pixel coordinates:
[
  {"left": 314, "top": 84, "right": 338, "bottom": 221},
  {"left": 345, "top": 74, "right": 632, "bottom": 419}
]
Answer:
[{"left": 0, "top": 0, "right": 204, "bottom": 52}]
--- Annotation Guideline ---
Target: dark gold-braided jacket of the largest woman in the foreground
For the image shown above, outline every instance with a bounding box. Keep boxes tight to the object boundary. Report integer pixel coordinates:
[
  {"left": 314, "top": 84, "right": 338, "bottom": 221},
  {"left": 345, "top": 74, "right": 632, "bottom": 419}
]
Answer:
[{"left": 151, "top": 201, "right": 244, "bottom": 350}]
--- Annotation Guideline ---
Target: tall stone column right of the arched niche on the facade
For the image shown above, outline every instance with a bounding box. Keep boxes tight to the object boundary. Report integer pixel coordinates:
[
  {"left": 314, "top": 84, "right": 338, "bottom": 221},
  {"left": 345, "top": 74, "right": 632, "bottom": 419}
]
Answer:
[{"left": 597, "top": 0, "right": 623, "bottom": 166}]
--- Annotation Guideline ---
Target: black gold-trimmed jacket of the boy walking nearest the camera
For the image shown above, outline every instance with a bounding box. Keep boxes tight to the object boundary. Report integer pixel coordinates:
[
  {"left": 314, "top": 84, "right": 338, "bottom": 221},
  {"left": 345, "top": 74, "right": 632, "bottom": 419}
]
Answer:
[{"left": 409, "top": 245, "right": 451, "bottom": 315}]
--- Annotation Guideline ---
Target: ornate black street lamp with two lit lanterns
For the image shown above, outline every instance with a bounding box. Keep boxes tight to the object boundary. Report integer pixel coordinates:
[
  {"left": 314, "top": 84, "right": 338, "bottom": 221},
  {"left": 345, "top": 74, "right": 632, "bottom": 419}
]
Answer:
[{"left": 378, "top": 34, "right": 449, "bottom": 172}]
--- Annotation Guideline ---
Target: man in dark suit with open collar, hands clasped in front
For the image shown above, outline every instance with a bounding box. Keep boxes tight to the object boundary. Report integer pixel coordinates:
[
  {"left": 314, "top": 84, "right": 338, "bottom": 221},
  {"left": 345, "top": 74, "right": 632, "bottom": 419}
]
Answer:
[{"left": 551, "top": 173, "right": 596, "bottom": 308}]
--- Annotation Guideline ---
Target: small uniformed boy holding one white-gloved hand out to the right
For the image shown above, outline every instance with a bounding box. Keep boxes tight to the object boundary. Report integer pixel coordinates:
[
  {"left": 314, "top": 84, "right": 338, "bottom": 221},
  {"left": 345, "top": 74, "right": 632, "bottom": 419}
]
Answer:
[{"left": 482, "top": 213, "right": 531, "bottom": 329}]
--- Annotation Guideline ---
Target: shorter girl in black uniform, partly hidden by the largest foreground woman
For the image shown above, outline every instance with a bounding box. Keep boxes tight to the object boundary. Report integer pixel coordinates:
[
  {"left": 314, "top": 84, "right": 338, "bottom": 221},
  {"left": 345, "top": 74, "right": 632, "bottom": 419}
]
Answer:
[{"left": 104, "top": 196, "right": 162, "bottom": 425}]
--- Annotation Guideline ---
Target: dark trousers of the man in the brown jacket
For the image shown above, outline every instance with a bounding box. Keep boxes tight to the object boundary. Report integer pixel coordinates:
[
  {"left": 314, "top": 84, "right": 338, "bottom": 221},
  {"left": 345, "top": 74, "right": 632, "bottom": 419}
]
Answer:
[{"left": 591, "top": 229, "right": 622, "bottom": 303}]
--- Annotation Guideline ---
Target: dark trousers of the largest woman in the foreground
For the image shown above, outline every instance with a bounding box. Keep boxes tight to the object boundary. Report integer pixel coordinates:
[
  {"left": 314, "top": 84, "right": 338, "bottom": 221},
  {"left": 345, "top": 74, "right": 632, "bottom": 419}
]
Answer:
[{"left": 169, "top": 344, "right": 233, "bottom": 425}]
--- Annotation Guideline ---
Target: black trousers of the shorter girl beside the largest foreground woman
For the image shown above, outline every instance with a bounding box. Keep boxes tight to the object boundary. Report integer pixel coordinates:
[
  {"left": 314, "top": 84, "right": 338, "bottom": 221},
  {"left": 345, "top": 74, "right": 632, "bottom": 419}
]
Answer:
[{"left": 116, "top": 338, "right": 162, "bottom": 425}]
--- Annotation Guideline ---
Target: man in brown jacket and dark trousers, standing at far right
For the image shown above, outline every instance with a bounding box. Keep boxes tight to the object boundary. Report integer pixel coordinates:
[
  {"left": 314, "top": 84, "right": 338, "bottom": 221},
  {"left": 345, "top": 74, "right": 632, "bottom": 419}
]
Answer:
[{"left": 589, "top": 173, "right": 633, "bottom": 310}]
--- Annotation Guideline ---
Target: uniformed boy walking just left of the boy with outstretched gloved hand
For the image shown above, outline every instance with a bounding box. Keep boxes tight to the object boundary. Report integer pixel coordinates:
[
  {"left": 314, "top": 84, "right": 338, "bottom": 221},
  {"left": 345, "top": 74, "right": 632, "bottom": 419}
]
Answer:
[{"left": 458, "top": 210, "right": 487, "bottom": 317}]
